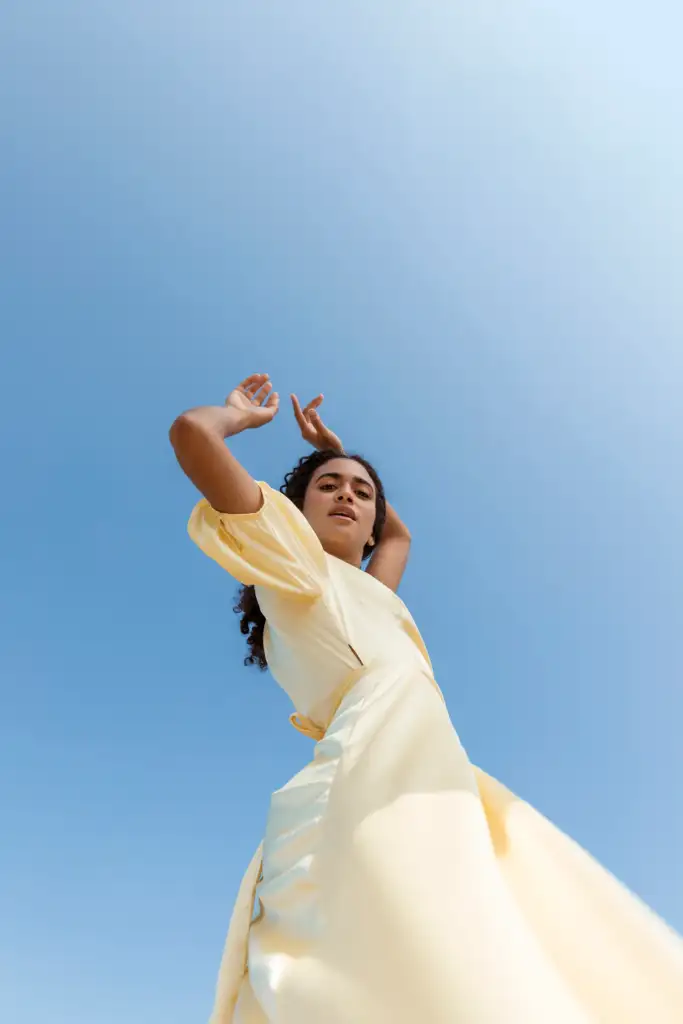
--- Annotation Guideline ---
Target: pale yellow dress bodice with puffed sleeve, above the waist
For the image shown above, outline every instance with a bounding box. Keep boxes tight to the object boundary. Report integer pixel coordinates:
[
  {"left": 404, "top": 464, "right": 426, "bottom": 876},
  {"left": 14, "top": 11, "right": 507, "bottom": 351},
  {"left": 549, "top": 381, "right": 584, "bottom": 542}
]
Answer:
[{"left": 188, "top": 483, "right": 431, "bottom": 722}]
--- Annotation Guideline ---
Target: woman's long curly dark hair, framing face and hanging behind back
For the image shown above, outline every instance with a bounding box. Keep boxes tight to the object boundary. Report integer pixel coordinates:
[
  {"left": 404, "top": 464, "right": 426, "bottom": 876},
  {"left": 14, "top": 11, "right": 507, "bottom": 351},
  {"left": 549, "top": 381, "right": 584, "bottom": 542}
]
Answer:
[{"left": 233, "top": 451, "right": 386, "bottom": 670}]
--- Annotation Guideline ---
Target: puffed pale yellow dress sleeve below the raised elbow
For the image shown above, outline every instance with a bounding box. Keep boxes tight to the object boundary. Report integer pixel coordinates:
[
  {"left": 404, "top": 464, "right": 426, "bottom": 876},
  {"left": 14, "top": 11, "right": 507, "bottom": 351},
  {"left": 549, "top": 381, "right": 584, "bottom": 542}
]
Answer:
[{"left": 187, "top": 481, "right": 327, "bottom": 598}]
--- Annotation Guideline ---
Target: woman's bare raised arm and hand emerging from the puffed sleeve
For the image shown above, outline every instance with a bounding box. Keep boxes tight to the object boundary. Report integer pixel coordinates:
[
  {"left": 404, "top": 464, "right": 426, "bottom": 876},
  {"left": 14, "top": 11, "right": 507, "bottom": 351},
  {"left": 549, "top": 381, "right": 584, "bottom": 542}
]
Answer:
[{"left": 169, "top": 374, "right": 279, "bottom": 514}]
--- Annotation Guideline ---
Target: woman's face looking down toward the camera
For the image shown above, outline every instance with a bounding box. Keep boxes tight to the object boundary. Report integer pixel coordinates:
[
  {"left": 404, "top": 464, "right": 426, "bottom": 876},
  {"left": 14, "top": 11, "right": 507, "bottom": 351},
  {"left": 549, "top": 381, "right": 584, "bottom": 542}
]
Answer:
[{"left": 303, "top": 459, "right": 376, "bottom": 565}]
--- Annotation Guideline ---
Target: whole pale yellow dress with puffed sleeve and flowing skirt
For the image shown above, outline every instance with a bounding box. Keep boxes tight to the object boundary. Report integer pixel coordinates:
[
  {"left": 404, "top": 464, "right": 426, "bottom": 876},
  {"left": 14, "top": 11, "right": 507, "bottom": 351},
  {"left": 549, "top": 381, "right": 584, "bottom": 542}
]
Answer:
[{"left": 188, "top": 483, "right": 683, "bottom": 1024}]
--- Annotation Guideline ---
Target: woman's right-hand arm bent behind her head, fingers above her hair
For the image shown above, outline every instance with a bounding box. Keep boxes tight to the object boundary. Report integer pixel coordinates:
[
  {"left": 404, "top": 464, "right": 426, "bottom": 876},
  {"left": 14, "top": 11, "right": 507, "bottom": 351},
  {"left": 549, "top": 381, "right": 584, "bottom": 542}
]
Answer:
[{"left": 292, "top": 394, "right": 411, "bottom": 591}]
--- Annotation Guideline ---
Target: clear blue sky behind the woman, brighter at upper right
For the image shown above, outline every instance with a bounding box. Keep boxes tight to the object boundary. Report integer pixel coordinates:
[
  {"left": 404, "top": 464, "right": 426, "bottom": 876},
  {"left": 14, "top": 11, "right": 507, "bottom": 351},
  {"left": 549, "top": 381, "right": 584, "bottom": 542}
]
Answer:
[{"left": 0, "top": 0, "right": 683, "bottom": 1024}]
